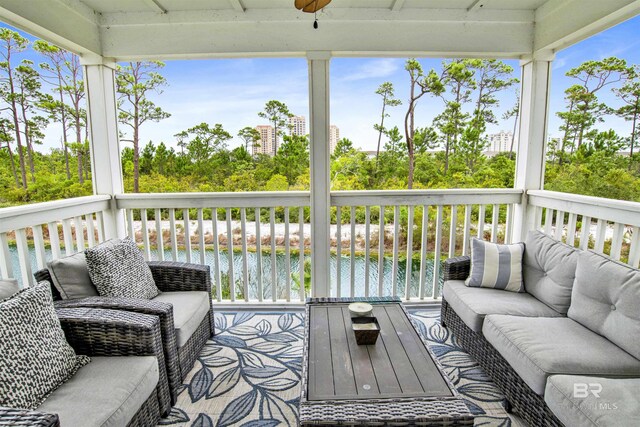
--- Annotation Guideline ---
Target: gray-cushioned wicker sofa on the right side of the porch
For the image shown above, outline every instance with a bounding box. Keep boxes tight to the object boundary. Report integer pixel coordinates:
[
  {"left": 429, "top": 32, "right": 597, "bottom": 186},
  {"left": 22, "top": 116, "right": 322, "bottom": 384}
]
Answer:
[{"left": 442, "top": 231, "right": 640, "bottom": 426}]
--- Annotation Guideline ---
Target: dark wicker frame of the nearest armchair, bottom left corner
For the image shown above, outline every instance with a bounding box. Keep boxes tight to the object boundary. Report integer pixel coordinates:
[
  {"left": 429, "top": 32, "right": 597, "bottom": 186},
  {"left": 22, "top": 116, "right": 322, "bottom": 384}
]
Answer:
[{"left": 0, "top": 308, "right": 171, "bottom": 427}]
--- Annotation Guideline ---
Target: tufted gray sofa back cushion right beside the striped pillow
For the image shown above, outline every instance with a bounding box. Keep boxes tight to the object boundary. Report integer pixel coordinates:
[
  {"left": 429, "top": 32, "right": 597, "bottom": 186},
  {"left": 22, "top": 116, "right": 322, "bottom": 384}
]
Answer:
[{"left": 522, "top": 230, "right": 579, "bottom": 314}]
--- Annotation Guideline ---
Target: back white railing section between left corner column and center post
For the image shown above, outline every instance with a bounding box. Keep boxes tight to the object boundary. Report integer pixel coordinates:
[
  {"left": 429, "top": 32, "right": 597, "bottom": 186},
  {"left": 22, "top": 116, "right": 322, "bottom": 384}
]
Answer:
[{"left": 116, "top": 191, "right": 310, "bottom": 302}]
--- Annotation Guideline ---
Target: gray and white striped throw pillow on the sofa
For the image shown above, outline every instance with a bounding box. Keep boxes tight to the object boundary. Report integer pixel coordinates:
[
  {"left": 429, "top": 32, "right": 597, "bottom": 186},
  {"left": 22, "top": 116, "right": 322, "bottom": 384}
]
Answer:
[{"left": 465, "top": 238, "right": 524, "bottom": 292}]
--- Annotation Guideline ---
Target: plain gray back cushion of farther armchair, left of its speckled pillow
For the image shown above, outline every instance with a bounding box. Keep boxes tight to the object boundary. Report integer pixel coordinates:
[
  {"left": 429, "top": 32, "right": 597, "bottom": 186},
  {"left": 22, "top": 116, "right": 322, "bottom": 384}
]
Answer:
[{"left": 47, "top": 252, "right": 98, "bottom": 299}]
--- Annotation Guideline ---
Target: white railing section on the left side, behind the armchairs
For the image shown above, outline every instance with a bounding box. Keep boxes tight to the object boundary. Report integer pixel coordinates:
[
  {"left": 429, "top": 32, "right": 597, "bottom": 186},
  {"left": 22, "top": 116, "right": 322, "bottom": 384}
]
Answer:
[{"left": 0, "top": 196, "right": 111, "bottom": 285}]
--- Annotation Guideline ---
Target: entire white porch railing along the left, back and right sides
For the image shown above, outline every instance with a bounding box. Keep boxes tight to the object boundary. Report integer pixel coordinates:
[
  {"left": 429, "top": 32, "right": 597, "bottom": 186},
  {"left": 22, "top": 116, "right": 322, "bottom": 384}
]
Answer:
[{"left": 5, "top": 189, "right": 640, "bottom": 303}]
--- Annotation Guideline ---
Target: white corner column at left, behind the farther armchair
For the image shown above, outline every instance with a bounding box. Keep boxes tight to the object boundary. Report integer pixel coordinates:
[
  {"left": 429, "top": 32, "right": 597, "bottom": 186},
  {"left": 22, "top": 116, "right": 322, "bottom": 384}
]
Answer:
[{"left": 83, "top": 58, "right": 126, "bottom": 239}]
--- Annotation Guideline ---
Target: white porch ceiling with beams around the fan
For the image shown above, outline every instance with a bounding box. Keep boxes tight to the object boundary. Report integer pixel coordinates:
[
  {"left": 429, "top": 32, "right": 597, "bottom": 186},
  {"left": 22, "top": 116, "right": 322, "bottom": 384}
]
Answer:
[{"left": 0, "top": 0, "right": 640, "bottom": 60}]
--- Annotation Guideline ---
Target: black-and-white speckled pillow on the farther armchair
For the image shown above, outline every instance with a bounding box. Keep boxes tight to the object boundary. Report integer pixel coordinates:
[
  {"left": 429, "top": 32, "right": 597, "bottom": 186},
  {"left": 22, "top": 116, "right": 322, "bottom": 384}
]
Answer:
[{"left": 85, "top": 237, "right": 160, "bottom": 299}]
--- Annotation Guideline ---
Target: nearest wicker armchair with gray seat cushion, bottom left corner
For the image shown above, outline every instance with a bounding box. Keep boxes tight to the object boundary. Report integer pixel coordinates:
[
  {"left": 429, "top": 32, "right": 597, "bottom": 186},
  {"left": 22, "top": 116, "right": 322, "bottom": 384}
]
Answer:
[{"left": 0, "top": 308, "right": 171, "bottom": 427}]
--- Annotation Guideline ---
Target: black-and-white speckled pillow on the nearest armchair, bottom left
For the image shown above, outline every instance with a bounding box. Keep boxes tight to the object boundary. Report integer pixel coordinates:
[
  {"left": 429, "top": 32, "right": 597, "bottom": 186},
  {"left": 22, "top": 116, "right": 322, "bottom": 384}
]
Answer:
[{"left": 0, "top": 282, "right": 89, "bottom": 409}]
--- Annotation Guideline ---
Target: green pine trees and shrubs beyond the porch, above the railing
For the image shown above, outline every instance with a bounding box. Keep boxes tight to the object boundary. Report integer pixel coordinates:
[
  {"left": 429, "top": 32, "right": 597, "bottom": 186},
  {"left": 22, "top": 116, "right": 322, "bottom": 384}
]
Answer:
[{"left": 0, "top": 28, "right": 640, "bottom": 206}]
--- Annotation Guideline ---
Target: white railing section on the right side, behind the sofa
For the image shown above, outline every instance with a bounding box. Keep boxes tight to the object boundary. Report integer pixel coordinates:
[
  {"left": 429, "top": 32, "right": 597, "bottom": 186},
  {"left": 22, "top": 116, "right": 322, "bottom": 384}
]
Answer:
[{"left": 528, "top": 191, "right": 640, "bottom": 268}]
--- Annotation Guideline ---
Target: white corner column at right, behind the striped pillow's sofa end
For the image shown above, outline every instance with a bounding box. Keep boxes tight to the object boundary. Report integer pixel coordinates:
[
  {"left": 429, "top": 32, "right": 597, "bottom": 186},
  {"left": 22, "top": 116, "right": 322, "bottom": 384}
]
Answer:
[{"left": 513, "top": 53, "right": 553, "bottom": 242}]
